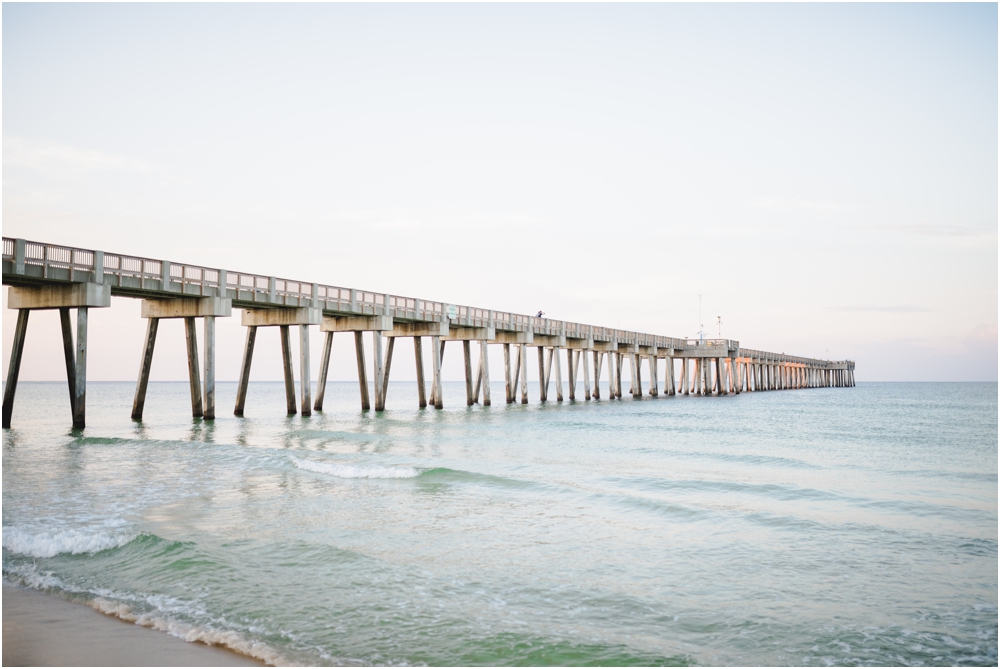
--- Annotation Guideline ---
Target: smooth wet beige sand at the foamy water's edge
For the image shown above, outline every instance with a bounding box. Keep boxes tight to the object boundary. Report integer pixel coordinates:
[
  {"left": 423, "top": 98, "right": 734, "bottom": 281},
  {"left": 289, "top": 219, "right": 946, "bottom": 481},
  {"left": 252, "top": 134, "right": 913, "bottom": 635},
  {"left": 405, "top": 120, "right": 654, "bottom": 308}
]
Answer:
[{"left": 3, "top": 585, "right": 263, "bottom": 667}]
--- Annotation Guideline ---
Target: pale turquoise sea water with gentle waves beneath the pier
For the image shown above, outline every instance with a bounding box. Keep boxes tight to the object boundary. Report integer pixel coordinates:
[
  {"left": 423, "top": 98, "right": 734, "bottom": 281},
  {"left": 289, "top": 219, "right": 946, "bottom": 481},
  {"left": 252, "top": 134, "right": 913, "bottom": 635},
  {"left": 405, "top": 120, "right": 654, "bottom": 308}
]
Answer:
[{"left": 3, "top": 383, "right": 997, "bottom": 666}]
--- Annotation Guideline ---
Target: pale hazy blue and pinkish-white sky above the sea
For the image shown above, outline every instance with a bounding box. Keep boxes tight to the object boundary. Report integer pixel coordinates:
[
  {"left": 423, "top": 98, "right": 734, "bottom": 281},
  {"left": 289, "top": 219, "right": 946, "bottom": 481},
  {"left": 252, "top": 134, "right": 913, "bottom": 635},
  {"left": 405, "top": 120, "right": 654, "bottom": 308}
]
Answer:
[{"left": 3, "top": 4, "right": 998, "bottom": 381}]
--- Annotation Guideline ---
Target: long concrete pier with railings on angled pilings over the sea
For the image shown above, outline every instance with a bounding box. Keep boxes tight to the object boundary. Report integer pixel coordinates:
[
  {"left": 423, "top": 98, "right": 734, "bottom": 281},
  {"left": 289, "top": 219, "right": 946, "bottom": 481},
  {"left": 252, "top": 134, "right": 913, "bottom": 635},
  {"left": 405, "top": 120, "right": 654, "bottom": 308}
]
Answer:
[{"left": 3, "top": 237, "right": 854, "bottom": 428}]
